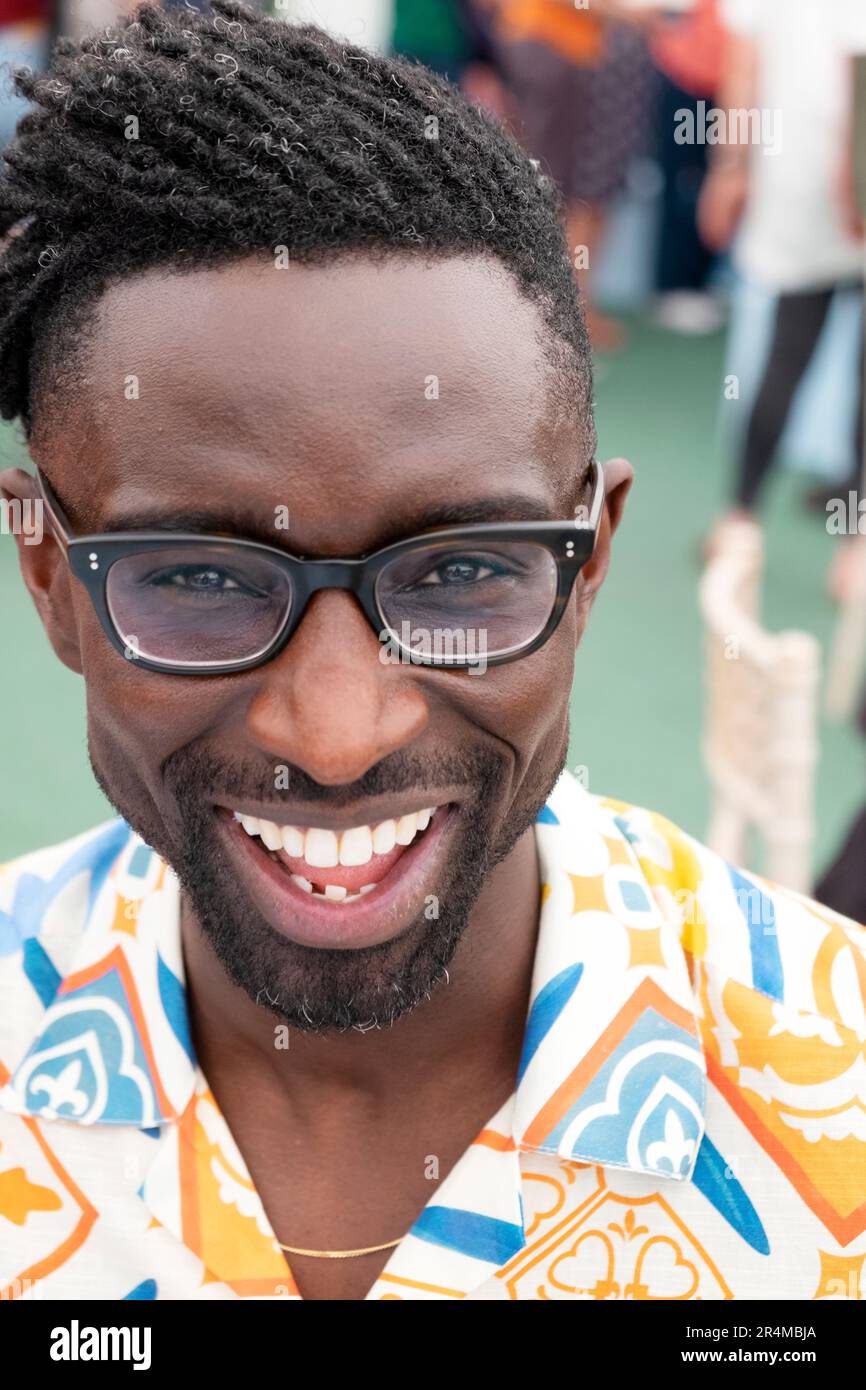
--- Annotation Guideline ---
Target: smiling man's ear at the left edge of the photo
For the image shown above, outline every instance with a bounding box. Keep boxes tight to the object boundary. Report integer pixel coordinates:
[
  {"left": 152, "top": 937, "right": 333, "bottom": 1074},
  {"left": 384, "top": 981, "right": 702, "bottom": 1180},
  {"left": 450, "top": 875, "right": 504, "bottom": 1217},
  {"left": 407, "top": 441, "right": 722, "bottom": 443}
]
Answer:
[{"left": 0, "top": 468, "right": 82, "bottom": 676}]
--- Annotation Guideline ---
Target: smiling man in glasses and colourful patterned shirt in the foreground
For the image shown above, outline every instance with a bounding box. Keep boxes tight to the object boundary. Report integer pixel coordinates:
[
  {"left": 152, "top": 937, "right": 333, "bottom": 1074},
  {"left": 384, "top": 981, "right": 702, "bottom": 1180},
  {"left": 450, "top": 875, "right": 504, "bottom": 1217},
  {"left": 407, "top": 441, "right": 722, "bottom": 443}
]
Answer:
[{"left": 0, "top": 0, "right": 866, "bottom": 1300}]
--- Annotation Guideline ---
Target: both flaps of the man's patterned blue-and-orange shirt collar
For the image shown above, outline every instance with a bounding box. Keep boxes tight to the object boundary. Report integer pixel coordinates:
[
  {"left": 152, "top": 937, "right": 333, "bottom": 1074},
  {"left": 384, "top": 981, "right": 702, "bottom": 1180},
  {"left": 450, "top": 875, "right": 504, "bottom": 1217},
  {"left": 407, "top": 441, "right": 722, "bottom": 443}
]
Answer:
[{"left": 0, "top": 773, "right": 706, "bottom": 1179}]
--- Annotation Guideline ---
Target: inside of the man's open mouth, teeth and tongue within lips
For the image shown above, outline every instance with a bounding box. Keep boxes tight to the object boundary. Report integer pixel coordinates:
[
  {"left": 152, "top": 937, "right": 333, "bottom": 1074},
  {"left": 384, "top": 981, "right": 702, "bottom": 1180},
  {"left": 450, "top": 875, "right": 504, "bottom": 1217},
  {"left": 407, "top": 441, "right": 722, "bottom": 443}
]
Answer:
[{"left": 234, "top": 806, "right": 443, "bottom": 906}]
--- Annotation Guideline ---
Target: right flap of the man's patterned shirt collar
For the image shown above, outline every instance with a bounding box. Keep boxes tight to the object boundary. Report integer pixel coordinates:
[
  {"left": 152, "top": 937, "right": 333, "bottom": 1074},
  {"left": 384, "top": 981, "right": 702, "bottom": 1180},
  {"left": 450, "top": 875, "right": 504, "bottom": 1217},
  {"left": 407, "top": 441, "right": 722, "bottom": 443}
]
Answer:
[{"left": 513, "top": 774, "right": 706, "bottom": 1179}]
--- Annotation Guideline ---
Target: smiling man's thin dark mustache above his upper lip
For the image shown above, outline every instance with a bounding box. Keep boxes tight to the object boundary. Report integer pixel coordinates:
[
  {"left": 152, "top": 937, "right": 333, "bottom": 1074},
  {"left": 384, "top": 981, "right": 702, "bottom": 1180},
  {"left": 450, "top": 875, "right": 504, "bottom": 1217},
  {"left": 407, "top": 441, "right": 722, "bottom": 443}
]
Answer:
[{"left": 163, "top": 745, "right": 507, "bottom": 810}]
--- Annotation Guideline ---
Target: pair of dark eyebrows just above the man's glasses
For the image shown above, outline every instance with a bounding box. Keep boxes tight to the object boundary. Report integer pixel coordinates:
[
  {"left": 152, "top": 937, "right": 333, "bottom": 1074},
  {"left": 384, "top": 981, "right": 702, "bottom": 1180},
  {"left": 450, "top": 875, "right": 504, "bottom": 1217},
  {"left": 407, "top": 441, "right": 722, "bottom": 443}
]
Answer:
[{"left": 94, "top": 493, "right": 557, "bottom": 549}]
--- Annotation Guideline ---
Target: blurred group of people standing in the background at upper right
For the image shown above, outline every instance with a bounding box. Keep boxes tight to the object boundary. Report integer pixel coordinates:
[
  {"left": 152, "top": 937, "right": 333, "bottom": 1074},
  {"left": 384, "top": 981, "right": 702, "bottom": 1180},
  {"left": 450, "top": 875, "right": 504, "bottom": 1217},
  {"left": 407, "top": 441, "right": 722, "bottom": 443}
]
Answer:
[{"left": 395, "top": 0, "right": 866, "bottom": 522}]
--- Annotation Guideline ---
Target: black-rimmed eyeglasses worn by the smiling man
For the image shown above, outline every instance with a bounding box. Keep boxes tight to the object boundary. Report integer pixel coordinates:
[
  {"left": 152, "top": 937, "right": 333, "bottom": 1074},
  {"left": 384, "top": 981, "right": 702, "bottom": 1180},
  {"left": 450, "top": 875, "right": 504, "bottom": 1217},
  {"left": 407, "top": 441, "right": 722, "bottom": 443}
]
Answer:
[{"left": 36, "top": 463, "right": 605, "bottom": 676}]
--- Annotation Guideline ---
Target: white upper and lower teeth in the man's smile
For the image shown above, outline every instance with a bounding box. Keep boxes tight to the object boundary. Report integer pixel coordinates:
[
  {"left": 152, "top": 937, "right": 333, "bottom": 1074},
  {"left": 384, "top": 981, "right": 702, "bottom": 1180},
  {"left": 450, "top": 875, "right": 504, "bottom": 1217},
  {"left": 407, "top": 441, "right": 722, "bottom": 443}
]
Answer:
[{"left": 235, "top": 806, "right": 436, "bottom": 867}]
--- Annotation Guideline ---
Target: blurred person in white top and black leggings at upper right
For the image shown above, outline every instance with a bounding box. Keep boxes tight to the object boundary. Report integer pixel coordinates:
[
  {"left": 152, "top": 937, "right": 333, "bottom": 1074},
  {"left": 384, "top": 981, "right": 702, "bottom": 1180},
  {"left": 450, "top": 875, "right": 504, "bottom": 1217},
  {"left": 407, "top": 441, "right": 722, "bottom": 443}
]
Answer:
[{"left": 699, "top": 0, "right": 866, "bottom": 552}]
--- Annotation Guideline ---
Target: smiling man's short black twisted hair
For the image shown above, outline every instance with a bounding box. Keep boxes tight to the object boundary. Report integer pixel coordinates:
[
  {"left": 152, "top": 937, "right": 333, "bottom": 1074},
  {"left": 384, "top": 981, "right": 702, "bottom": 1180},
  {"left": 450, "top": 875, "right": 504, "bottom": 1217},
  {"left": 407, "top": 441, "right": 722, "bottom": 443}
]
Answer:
[{"left": 0, "top": 0, "right": 594, "bottom": 443}]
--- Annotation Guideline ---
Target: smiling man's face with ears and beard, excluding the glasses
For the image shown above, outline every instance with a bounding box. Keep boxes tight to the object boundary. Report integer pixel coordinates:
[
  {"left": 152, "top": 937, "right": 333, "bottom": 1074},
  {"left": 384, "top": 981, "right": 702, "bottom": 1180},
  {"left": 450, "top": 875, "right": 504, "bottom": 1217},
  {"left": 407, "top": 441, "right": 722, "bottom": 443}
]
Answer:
[{"left": 10, "top": 257, "right": 627, "bottom": 1029}]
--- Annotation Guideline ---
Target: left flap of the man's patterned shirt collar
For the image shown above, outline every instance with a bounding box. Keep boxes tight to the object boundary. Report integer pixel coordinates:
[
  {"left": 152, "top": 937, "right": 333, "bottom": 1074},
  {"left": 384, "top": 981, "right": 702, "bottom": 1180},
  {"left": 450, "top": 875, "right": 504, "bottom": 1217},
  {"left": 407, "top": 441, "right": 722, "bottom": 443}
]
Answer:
[{"left": 0, "top": 821, "right": 196, "bottom": 1129}]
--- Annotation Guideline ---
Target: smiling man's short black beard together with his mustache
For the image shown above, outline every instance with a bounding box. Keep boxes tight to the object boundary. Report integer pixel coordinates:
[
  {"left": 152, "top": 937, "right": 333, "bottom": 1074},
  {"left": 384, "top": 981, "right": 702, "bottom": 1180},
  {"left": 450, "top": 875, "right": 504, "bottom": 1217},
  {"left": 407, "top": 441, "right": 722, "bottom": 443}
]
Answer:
[{"left": 92, "top": 745, "right": 564, "bottom": 1033}]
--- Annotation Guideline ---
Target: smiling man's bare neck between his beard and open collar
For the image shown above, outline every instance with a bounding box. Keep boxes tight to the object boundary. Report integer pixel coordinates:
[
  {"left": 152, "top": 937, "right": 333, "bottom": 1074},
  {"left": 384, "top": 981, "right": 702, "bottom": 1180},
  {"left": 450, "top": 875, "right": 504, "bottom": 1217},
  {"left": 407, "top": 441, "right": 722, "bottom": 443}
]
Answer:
[{"left": 182, "top": 830, "right": 539, "bottom": 1111}]
